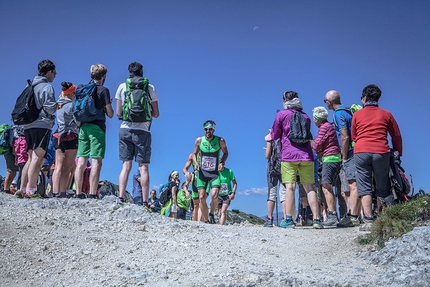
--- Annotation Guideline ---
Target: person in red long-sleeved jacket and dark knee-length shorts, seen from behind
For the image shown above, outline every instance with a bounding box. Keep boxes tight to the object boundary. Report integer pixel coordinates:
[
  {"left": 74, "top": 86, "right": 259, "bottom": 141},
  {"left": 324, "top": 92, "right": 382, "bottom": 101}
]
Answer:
[{"left": 352, "top": 84, "right": 402, "bottom": 231}]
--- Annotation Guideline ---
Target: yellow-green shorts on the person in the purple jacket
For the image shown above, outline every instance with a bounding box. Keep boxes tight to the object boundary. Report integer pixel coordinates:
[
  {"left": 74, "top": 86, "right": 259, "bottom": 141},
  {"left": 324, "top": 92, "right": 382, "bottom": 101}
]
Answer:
[{"left": 281, "top": 161, "right": 315, "bottom": 184}]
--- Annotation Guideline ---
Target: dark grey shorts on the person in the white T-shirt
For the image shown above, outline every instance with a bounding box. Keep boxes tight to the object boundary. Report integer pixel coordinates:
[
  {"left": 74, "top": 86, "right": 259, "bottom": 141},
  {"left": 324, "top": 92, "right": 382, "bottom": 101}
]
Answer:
[{"left": 118, "top": 129, "right": 151, "bottom": 164}]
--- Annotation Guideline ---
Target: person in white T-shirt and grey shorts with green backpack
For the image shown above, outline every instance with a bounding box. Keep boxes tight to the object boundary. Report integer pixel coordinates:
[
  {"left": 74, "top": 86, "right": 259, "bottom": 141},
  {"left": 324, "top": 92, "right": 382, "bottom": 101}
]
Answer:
[{"left": 115, "top": 62, "right": 160, "bottom": 208}]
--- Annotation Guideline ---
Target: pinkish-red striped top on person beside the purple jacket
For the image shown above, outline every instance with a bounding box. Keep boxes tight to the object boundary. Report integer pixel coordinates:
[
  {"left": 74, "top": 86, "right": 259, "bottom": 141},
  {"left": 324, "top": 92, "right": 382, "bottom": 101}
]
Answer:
[{"left": 312, "top": 121, "right": 340, "bottom": 156}]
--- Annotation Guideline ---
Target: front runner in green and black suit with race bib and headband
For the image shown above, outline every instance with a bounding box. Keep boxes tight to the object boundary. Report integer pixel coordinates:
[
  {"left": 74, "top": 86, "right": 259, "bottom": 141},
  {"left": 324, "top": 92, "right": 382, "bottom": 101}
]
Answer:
[{"left": 193, "top": 120, "right": 228, "bottom": 224}]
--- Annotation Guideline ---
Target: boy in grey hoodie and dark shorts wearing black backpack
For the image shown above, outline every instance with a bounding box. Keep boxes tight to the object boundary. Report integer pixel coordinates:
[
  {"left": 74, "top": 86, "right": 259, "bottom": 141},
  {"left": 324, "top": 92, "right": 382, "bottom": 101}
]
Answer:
[{"left": 12, "top": 60, "right": 57, "bottom": 198}]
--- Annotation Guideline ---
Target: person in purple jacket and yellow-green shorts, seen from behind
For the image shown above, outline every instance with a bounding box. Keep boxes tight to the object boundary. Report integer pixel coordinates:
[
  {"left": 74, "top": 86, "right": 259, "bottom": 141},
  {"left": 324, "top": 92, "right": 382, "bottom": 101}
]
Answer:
[{"left": 271, "top": 91, "right": 324, "bottom": 229}]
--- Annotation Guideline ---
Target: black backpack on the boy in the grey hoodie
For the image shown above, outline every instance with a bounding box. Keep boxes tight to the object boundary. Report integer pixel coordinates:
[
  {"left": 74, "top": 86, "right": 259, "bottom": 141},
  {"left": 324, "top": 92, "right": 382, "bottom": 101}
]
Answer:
[{"left": 12, "top": 80, "right": 42, "bottom": 125}]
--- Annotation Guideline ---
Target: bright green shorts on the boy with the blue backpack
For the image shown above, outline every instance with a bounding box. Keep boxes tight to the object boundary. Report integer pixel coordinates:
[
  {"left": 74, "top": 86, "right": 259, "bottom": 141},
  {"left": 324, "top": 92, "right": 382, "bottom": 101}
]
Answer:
[{"left": 78, "top": 123, "right": 106, "bottom": 158}]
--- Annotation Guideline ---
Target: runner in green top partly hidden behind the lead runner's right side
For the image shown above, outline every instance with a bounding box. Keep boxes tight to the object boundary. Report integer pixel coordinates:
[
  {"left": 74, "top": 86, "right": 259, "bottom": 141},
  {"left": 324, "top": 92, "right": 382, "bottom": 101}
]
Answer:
[{"left": 218, "top": 168, "right": 237, "bottom": 225}]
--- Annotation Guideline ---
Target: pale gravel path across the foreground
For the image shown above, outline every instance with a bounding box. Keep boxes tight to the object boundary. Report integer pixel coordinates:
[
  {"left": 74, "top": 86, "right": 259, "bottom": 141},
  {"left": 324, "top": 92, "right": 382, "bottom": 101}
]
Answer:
[{"left": 0, "top": 194, "right": 430, "bottom": 286}]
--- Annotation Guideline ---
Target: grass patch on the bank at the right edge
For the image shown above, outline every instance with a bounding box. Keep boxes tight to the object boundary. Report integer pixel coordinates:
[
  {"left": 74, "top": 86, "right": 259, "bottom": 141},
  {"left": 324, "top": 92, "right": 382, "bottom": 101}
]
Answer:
[{"left": 358, "top": 194, "right": 430, "bottom": 248}]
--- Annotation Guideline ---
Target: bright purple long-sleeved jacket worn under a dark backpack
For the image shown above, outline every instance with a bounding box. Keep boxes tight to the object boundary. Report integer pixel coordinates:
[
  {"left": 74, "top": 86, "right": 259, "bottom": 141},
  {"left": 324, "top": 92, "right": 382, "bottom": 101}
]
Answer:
[{"left": 271, "top": 109, "right": 314, "bottom": 162}]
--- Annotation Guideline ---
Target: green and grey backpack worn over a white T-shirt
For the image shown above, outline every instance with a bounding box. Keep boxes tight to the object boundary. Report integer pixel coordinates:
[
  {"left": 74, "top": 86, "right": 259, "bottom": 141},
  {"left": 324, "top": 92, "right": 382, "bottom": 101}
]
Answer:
[{"left": 122, "top": 77, "right": 152, "bottom": 123}]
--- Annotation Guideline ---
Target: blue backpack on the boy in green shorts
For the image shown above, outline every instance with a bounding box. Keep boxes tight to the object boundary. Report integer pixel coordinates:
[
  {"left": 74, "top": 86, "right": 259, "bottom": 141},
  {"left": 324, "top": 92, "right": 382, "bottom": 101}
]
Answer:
[{"left": 73, "top": 81, "right": 105, "bottom": 123}]
